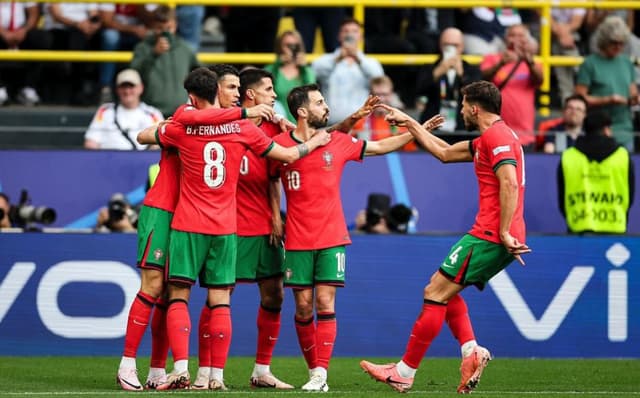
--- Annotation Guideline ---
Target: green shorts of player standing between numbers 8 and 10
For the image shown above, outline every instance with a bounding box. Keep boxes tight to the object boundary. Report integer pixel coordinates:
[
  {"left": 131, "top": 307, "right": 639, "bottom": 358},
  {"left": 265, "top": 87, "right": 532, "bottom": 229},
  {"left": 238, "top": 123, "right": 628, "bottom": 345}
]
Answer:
[{"left": 236, "top": 235, "right": 284, "bottom": 282}]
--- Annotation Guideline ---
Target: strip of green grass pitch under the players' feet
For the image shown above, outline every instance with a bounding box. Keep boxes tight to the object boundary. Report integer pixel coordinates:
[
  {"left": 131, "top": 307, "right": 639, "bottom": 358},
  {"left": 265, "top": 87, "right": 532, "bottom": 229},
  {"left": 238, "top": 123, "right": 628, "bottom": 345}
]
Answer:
[{"left": 0, "top": 357, "right": 640, "bottom": 398}]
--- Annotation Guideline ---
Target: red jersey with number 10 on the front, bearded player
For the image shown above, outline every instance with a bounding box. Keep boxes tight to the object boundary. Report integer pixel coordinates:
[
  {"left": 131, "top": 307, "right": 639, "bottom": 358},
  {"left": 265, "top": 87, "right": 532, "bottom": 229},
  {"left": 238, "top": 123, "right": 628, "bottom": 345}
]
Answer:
[{"left": 272, "top": 132, "right": 366, "bottom": 250}]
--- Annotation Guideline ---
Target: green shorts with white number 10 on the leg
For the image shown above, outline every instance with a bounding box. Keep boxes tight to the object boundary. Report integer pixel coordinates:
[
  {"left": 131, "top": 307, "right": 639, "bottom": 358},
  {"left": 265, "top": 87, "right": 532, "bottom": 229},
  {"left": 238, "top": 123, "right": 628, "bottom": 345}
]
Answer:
[{"left": 284, "top": 246, "right": 346, "bottom": 289}]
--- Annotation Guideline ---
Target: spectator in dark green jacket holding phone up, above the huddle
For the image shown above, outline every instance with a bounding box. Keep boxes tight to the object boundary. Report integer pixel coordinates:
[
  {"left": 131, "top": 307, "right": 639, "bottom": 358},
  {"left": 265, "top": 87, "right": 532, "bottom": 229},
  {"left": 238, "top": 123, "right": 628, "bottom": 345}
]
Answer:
[{"left": 131, "top": 6, "right": 198, "bottom": 115}]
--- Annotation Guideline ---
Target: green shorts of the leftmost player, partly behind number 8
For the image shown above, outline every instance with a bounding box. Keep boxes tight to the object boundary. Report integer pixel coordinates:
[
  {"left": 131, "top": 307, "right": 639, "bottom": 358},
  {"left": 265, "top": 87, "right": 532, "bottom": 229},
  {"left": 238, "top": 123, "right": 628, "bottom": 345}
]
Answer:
[{"left": 137, "top": 206, "right": 173, "bottom": 271}]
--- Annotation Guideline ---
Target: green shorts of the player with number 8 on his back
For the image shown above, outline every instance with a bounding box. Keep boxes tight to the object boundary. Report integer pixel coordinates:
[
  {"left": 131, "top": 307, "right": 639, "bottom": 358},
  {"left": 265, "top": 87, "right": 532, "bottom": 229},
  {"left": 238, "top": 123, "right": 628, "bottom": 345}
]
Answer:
[{"left": 168, "top": 230, "right": 237, "bottom": 287}]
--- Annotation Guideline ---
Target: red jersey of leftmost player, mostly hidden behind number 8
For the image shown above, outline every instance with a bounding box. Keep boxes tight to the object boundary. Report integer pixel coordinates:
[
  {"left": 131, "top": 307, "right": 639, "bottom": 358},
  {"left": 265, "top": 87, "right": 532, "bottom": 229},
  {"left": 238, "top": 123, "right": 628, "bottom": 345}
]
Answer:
[{"left": 142, "top": 105, "right": 242, "bottom": 213}]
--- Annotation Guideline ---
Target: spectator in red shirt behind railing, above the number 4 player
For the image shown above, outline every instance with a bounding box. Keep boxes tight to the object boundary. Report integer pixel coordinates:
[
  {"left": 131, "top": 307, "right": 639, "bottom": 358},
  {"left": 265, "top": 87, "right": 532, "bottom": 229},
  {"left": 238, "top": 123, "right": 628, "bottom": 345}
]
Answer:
[{"left": 480, "top": 25, "right": 542, "bottom": 151}]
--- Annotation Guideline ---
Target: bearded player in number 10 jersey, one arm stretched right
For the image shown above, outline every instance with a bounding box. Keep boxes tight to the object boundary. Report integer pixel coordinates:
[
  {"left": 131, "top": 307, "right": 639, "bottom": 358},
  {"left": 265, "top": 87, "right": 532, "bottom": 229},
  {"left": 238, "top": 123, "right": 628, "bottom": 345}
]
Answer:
[{"left": 271, "top": 84, "right": 432, "bottom": 392}]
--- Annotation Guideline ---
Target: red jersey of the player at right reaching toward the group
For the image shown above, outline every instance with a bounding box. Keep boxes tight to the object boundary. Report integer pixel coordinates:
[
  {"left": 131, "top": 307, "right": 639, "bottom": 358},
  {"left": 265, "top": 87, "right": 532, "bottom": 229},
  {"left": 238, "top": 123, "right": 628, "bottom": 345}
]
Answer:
[{"left": 469, "top": 121, "right": 526, "bottom": 243}]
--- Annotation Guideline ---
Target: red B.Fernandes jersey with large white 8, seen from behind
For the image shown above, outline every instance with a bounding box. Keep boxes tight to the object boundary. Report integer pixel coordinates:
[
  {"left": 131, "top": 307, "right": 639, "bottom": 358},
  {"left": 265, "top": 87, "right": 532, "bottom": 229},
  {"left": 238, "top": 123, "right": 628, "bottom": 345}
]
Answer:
[{"left": 158, "top": 120, "right": 273, "bottom": 235}]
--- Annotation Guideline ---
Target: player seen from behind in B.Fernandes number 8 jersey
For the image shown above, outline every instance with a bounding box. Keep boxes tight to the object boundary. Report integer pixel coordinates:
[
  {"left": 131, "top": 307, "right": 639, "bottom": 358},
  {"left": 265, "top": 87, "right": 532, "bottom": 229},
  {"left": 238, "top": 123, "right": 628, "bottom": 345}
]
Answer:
[{"left": 138, "top": 68, "right": 330, "bottom": 390}]
